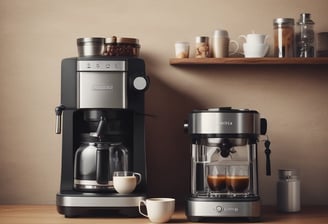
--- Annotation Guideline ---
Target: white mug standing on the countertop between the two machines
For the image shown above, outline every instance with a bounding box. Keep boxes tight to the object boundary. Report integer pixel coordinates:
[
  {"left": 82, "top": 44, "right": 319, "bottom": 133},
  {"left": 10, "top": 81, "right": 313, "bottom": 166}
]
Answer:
[{"left": 139, "top": 198, "right": 175, "bottom": 223}]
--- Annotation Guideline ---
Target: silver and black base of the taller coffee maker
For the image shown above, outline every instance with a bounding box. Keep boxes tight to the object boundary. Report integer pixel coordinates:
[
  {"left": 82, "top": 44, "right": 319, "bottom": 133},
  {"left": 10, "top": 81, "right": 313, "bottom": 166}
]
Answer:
[{"left": 56, "top": 193, "right": 146, "bottom": 218}]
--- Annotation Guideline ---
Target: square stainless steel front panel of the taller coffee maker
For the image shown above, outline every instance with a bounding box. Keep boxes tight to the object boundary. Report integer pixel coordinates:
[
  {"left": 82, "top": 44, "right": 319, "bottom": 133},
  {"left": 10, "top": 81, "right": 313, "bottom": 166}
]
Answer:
[{"left": 77, "top": 72, "right": 128, "bottom": 109}]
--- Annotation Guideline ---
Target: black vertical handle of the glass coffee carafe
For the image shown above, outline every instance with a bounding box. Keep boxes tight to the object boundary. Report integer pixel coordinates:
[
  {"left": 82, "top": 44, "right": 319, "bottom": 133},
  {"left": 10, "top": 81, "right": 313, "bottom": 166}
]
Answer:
[{"left": 96, "top": 144, "right": 109, "bottom": 184}]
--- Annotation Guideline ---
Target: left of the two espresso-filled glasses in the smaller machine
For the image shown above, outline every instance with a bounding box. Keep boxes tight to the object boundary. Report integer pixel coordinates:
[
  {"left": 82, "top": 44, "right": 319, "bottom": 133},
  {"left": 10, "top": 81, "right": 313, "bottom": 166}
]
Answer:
[{"left": 207, "top": 164, "right": 226, "bottom": 192}]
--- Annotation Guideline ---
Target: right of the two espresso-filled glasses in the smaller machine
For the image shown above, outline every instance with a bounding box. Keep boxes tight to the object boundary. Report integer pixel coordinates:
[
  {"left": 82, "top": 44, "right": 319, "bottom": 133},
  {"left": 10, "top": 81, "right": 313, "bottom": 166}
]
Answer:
[{"left": 226, "top": 164, "right": 249, "bottom": 193}]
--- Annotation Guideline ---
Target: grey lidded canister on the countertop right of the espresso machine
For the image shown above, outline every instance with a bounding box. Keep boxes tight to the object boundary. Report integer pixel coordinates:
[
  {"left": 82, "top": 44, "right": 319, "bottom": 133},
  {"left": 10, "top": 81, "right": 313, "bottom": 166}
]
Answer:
[{"left": 277, "top": 169, "right": 301, "bottom": 212}]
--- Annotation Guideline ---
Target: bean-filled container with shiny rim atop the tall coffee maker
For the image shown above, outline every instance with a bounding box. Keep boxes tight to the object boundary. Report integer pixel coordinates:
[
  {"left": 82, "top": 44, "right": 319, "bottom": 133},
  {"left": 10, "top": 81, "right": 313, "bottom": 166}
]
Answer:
[{"left": 104, "top": 36, "right": 140, "bottom": 57}]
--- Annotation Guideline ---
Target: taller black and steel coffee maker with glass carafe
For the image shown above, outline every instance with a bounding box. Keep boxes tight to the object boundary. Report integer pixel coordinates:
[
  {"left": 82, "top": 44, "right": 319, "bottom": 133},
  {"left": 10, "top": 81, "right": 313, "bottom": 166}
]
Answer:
[{"left": 56, "top": 56, "right": 149, "bottom": 217}]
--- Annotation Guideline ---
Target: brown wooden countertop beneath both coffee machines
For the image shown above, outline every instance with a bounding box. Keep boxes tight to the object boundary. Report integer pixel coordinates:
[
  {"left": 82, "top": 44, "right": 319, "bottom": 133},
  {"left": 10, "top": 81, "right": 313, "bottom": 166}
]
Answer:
[{"left": 0, "top": 205, "right": 328, "bottom": 224}]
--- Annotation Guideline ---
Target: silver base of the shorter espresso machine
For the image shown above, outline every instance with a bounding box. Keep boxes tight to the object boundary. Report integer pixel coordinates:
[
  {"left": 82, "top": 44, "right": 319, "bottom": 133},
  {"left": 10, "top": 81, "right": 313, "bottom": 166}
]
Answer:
[{"left": 186, "top": 197, "right": 261, "bottom": 222}]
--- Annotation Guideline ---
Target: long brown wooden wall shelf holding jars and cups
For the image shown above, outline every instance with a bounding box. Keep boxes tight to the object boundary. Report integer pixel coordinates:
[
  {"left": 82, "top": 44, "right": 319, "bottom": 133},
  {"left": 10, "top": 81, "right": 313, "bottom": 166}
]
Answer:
[{"left": 170, "top": 57, "right": 328, "bottom": 65}]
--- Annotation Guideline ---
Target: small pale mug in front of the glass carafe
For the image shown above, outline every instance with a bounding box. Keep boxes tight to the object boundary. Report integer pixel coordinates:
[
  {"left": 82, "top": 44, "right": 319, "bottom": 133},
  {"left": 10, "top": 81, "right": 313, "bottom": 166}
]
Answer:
[{"left": 113, "top": 171, "right": 141, "bottom": 194}]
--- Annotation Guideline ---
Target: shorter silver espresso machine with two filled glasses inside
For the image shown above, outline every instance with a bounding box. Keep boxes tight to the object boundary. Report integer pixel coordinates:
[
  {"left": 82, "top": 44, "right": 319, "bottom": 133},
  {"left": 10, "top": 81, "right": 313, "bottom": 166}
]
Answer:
[{"left": 185, "top": 107, "right": 271, "bottom": 222}]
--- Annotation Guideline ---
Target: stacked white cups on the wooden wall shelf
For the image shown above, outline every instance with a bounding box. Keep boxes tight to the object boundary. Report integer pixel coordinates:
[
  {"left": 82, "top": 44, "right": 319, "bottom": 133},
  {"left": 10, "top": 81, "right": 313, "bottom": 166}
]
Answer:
[{"left": 240, "top": 33, "right": 269, "bottom": 58}]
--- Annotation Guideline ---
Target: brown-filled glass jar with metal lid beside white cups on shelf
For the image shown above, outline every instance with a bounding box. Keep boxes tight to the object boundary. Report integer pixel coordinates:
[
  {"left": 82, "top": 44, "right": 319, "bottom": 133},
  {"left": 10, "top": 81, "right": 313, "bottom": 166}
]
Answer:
[{"left": 273, "top": 18, "right": 295, "bottom": 58}]
